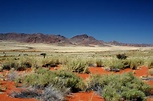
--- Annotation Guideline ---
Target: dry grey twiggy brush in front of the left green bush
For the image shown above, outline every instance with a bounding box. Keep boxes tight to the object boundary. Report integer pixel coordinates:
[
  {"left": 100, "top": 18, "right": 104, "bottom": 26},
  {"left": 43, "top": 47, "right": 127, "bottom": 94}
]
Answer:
[{"left": 9, "top": 86, "right": 67, "bottom": 101}]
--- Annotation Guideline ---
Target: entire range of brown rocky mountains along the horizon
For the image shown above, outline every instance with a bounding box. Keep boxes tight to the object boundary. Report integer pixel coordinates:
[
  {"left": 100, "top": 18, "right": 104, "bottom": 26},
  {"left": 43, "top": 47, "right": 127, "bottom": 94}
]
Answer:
[{"left": 0, "top": 33, "right": 153, "bottom": 47}]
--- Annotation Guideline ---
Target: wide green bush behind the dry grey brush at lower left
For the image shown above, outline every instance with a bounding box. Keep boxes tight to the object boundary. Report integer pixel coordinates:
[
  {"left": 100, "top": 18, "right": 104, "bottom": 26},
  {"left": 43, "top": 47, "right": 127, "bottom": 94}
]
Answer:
[{"left": 16, "top": 68, "right": 85, "bottom": 92}]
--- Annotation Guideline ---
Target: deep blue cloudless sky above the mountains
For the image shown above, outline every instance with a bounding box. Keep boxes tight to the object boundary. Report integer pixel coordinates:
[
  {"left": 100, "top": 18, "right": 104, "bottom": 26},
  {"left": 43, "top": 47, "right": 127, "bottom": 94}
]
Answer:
[{"left": 0, "top": 0, "right": 153, "bottom": 44}]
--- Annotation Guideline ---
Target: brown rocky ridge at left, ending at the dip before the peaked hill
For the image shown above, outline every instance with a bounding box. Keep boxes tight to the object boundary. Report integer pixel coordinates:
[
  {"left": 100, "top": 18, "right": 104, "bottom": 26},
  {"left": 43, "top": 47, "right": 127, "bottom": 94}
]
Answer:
[{"left": 0, "top": 33, "right": 71, "bottom": 45}]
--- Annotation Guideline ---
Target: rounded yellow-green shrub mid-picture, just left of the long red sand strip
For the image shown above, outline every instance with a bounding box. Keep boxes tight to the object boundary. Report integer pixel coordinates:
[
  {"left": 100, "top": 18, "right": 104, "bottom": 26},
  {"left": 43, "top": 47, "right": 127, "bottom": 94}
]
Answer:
[{"left": 64, "top": 59, "right": 89, "bottom": 73}]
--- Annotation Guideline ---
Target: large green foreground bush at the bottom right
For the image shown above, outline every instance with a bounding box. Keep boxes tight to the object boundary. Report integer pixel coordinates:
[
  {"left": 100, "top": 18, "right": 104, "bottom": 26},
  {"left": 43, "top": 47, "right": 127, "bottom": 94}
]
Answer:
[{"left": 87, "top": 73, "right": 151, "bottom": 101}]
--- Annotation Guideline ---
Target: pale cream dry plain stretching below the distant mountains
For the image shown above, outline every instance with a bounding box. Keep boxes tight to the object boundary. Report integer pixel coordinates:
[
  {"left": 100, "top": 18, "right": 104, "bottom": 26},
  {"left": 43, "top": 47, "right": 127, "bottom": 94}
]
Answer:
[{"left": 0, "top": 41, "right": 153, "bottom": 53}]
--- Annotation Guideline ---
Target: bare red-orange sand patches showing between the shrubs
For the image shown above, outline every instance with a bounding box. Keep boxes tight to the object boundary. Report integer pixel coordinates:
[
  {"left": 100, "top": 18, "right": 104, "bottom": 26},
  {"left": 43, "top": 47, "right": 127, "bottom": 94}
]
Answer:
[{"left": 0, "top": 67, "right": 153, "bottom": 101}]
